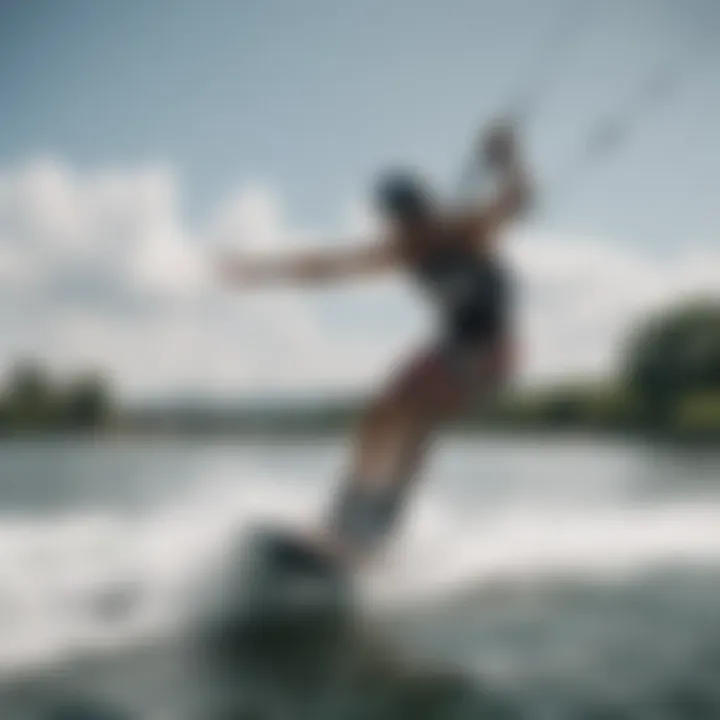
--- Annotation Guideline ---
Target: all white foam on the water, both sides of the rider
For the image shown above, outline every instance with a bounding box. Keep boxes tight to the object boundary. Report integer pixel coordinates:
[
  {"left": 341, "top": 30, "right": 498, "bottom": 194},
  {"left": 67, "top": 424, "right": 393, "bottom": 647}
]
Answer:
[{"left": 0, "top": 464, "right": 720, "bottom": 672}]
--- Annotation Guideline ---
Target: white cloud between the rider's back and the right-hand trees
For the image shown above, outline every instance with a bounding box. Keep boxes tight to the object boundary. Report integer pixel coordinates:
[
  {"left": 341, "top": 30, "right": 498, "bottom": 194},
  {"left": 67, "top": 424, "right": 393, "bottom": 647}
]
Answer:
[{"left": 510, "top": 231, "right": 720, "bottom": 388}]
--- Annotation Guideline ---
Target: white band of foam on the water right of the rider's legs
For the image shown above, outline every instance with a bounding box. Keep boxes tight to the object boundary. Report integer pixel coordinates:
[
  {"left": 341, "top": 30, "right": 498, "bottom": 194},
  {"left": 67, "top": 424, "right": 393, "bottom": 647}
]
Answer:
[{"left": 372, "top": 502, "right": 720, "bottom": 602}]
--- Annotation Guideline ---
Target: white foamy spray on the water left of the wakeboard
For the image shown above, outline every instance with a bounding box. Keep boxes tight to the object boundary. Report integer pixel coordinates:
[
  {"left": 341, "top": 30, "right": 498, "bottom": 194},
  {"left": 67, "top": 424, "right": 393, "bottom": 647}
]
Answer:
[{"left": 0, "top": 466, "right": 320, "bottom": 672}]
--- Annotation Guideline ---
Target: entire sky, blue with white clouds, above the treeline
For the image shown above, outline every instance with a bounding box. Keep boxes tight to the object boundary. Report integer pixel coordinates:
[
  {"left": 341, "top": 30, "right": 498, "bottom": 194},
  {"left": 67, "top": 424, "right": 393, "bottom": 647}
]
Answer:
[{"left": 0, "top": 0, "right": 720, "bottom": 398}]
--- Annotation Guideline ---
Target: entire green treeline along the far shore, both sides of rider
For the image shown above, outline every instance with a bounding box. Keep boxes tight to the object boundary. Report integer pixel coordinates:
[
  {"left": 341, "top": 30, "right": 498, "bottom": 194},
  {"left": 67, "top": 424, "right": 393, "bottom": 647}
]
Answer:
[{"left": 0, "top": 300, "right": 720, "bottom": 442}]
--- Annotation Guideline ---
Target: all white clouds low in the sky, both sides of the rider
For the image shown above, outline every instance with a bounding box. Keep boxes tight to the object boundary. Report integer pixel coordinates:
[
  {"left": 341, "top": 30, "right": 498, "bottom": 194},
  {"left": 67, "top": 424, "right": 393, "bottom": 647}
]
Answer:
[{"left": 0, "top": 161, "right": 720, "bottom": 402}]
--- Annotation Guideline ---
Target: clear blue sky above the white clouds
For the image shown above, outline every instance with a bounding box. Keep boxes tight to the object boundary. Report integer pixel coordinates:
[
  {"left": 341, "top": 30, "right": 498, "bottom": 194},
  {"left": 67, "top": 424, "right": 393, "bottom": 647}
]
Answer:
[{"left": 0, "top": 0, "right": 720, "bottom": 244}]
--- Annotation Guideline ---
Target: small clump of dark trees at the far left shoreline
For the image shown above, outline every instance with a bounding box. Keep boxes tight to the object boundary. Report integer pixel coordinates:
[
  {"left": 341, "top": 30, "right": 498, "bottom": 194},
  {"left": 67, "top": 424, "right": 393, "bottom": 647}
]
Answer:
[{"left": 0, "top": 361, "right": 113, "bottom": 435}]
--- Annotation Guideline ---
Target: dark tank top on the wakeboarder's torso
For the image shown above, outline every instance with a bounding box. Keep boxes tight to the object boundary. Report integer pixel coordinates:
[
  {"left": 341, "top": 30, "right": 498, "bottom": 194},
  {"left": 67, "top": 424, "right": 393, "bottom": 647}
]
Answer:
[{"left": 414, "top": 246, "right": 511, "bottom": 346}]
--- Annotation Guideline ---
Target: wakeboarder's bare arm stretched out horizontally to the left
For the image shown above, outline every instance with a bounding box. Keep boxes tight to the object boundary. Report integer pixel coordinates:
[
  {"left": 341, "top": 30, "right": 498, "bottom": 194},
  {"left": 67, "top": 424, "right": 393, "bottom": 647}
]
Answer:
[{"left": 220, "top": 242, "right": 395, "bottom": 287}]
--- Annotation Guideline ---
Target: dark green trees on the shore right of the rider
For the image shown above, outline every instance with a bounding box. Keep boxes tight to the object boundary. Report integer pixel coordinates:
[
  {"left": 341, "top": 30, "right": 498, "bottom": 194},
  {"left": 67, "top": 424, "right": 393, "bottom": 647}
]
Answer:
[{"left": 471, "top": 300, "right": 720, "bottom": 441}]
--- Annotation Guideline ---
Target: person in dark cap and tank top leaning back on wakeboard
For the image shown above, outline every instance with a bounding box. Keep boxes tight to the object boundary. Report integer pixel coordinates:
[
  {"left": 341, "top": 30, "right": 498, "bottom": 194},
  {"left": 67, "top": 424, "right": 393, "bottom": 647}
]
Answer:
[{"left": 220, "top": 123, "right": 531, "bottom": 567}]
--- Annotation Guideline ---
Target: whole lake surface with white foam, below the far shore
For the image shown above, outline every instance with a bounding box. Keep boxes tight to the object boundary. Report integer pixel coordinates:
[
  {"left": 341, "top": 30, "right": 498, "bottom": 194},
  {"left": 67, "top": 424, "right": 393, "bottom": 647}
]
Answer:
[{"left": 0, "top": 437, "right": 720, "bottom": 720}]
